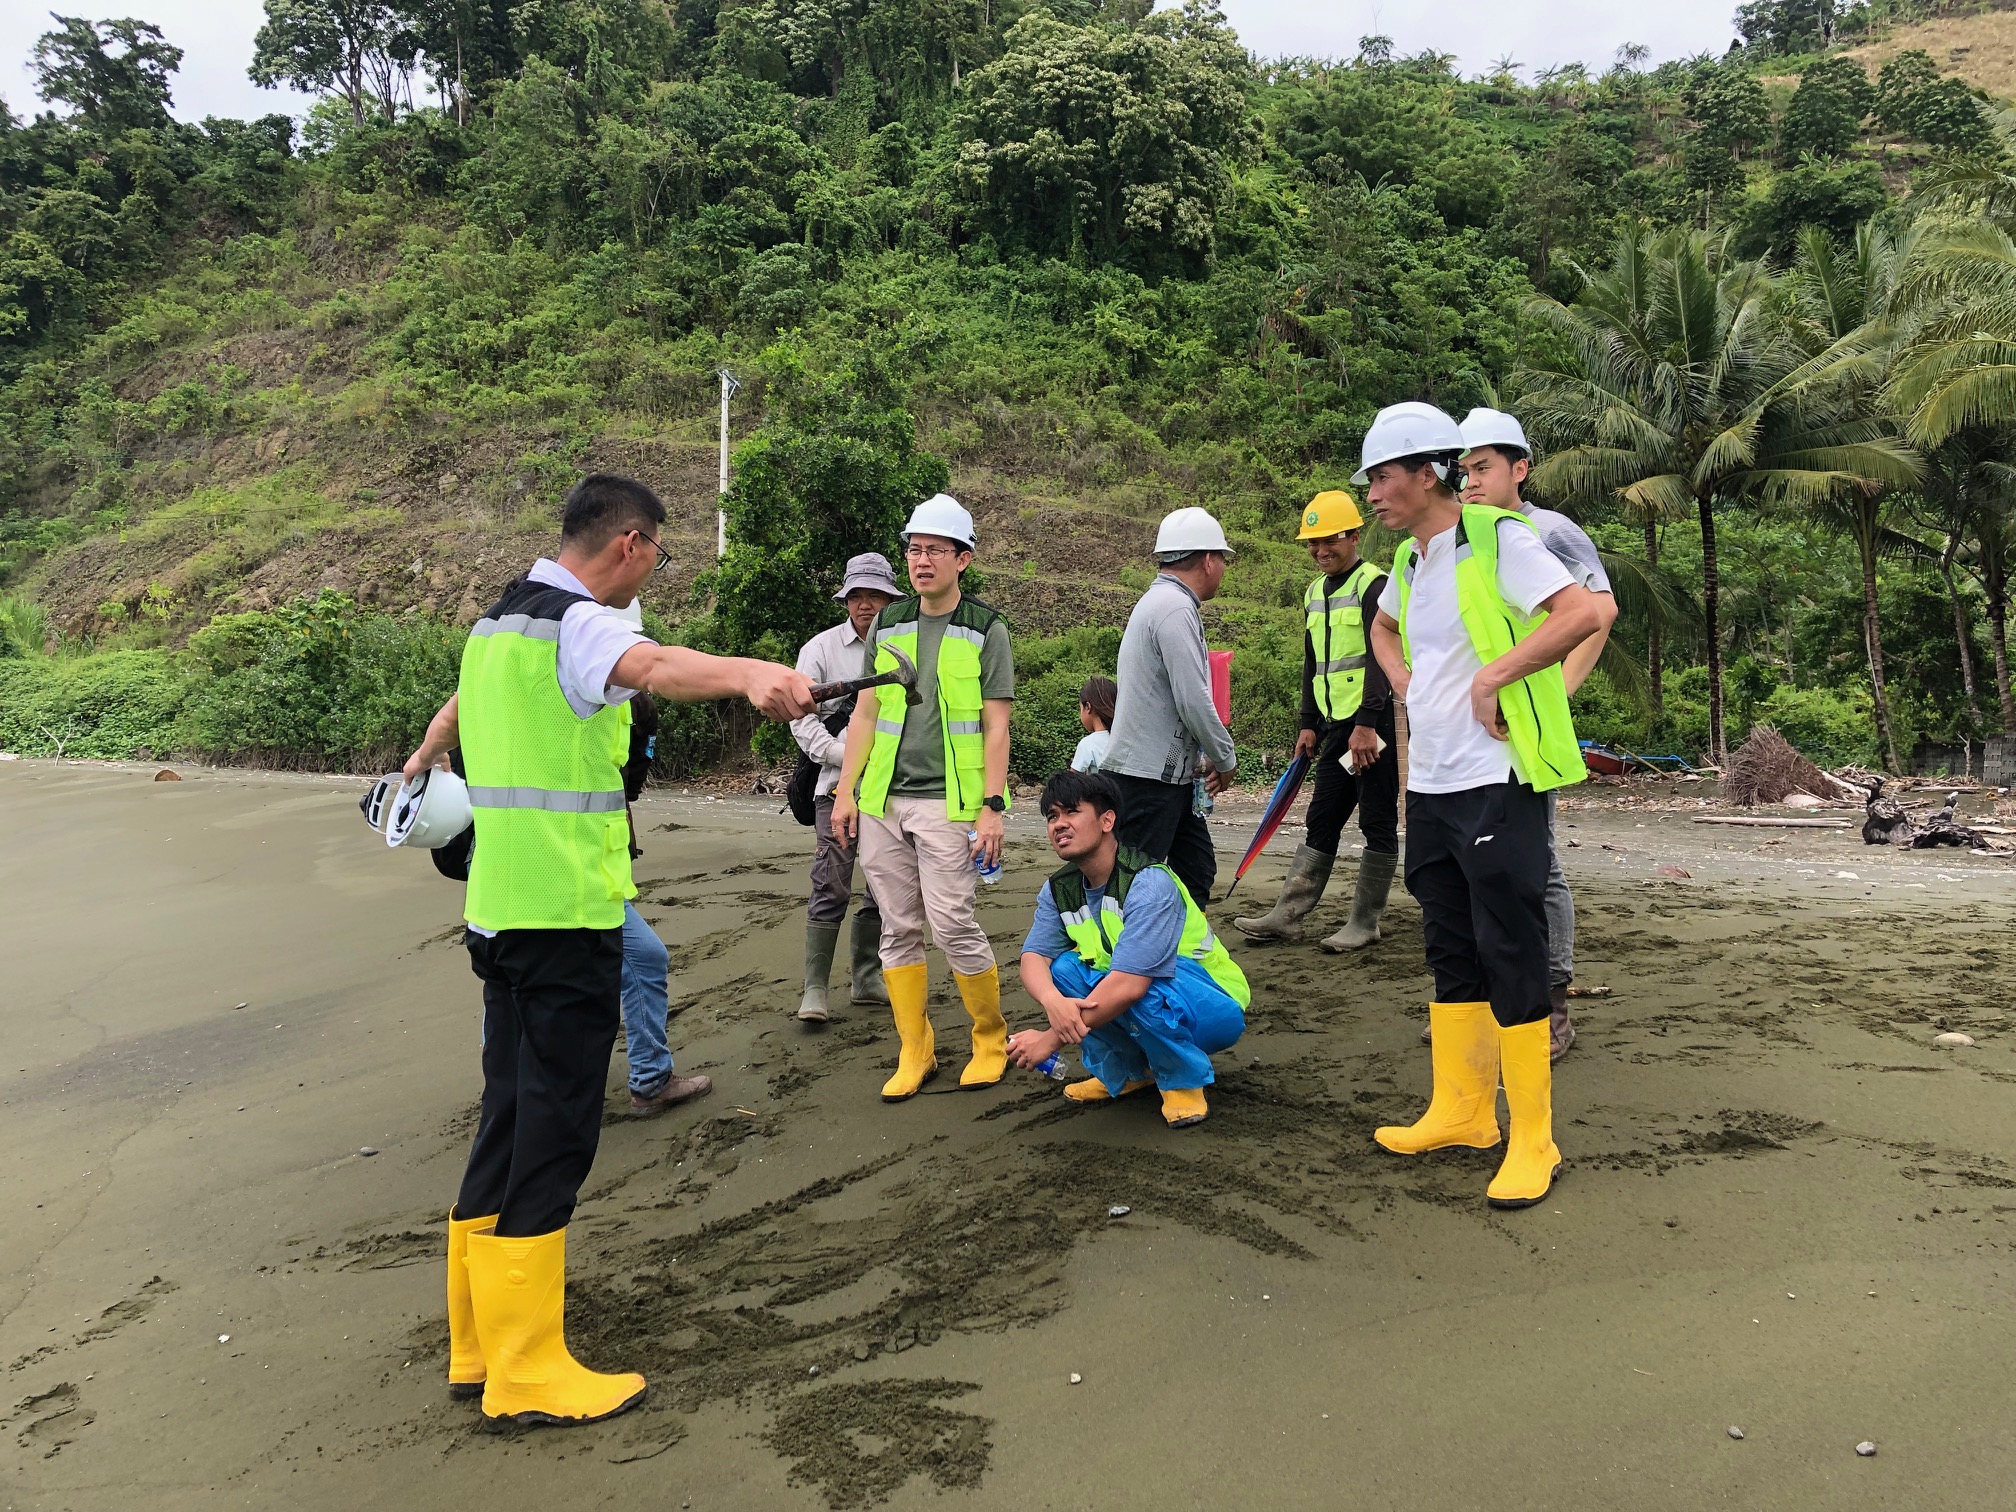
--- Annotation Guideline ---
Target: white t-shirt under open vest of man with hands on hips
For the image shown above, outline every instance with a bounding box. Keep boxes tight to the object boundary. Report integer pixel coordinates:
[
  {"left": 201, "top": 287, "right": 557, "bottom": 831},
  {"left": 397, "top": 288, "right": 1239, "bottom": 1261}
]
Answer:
[{"left": 1379, "top": 520, "right": 1574, "bottom": 792}]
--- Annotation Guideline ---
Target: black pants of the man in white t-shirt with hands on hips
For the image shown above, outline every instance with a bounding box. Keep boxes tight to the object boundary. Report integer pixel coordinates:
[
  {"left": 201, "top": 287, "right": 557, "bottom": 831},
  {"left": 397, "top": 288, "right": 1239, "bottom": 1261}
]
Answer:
[{"left": 1407, "top": 782, "right": 1550, "bottom": 1028}]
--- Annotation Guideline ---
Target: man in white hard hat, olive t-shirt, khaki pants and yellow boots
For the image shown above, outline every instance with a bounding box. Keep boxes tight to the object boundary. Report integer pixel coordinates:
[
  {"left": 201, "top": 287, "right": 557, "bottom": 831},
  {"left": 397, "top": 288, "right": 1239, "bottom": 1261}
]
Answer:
[{"left": 831, "top": 494, "right": 1014, "bottom": 1103}]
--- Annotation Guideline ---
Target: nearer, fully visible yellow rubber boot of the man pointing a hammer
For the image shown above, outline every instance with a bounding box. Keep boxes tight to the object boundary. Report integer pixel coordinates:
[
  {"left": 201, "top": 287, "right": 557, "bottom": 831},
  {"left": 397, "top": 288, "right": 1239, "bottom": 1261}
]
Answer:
[{"left": 470, "top": 1228, "right": 643, "bottom": 1427}]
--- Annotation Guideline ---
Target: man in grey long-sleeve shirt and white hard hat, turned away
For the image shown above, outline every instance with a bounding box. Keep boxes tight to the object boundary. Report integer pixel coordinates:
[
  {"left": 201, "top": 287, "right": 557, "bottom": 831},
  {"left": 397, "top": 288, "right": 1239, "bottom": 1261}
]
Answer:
[{"left": 1099, "top": 508, "right": 1238, "bottom": 907}]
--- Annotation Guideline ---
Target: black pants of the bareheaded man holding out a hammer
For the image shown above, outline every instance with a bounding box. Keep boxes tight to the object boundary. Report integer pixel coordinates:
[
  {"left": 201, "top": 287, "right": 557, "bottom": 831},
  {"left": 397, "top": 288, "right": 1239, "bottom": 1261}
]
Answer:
[{"left": 456, "top": 927, "right": 623, "bottom": 1238}]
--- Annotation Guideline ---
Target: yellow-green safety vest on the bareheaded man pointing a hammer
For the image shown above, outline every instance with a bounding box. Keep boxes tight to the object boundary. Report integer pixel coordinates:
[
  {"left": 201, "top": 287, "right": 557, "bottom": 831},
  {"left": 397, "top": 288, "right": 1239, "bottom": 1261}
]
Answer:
[{"left": 456, "top": 579, "right": 637, "bottom": 929}]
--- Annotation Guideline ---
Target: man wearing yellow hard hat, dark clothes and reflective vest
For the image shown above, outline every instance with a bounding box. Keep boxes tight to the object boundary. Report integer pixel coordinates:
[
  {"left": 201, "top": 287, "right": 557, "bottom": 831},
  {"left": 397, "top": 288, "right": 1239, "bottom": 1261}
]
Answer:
[{"left": 1232, "top": 488, "right": 1399, "bottom": 952}]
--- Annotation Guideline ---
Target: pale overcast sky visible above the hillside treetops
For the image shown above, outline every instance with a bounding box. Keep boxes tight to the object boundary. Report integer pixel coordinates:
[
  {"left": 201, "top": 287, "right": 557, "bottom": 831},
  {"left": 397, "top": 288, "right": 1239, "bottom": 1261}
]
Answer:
[{"left": 0, "top": 0, "right": 1736, "bottom": 121}]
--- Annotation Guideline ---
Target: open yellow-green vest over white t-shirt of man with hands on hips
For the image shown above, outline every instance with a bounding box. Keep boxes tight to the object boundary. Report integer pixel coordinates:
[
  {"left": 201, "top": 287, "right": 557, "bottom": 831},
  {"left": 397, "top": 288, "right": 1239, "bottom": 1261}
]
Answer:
[{"left": 1393, "top": 504, "right": 1589, "bottom": 792}]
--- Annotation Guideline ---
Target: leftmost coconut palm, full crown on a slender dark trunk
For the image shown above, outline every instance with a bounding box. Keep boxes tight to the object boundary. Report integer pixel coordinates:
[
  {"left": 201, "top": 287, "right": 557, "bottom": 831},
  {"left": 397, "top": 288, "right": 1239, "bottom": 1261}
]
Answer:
[{"left": 1514, "top": 230, "right": 1917, "bottom": 764}]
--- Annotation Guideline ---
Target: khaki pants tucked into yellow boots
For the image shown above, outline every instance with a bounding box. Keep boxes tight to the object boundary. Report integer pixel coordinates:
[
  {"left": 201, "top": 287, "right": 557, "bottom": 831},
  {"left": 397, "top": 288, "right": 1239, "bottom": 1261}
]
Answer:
[{"left": 861, "top": 798, "right": 994, "bottom": 976}]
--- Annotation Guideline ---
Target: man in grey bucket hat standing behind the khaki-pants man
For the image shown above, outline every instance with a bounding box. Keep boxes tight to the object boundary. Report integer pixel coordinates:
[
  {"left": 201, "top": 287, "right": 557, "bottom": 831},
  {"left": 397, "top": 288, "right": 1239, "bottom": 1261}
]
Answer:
[{"left": 790, "top": 550, "right": 903, "bottom": 1024}]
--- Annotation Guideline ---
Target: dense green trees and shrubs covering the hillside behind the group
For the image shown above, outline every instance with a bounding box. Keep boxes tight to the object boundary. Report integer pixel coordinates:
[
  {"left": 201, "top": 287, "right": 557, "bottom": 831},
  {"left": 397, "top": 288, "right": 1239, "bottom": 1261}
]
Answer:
[{"left": 0, "top": 0, "right": 2016, "bottom": 774}]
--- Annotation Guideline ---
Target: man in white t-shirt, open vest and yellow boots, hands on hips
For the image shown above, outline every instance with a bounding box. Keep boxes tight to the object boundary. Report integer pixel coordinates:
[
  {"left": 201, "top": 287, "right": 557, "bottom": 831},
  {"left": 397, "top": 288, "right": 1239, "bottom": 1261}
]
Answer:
[{"left": 1355, "top": 403, "right": 1597, "bottom": 1208}]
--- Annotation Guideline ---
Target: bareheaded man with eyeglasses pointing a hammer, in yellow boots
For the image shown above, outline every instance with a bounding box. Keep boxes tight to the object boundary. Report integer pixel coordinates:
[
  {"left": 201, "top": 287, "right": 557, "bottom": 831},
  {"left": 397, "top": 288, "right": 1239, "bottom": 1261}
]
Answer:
[{"left": 405, "top": 474, "right": 812, "bottom": 1427}]
